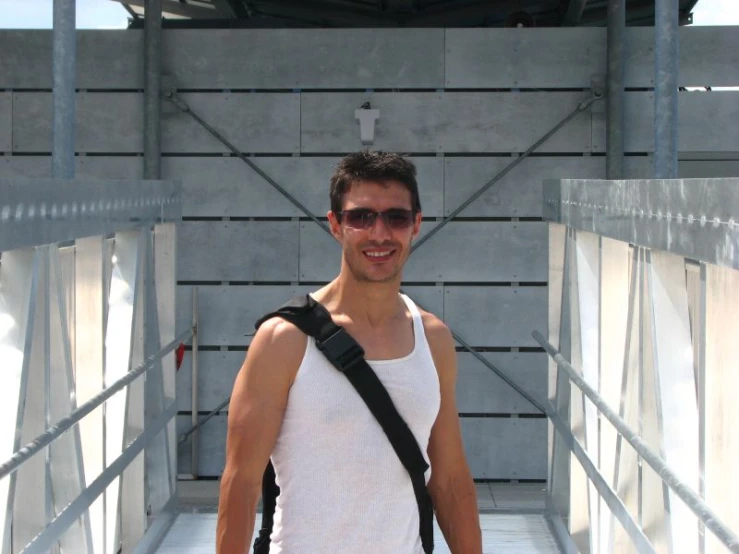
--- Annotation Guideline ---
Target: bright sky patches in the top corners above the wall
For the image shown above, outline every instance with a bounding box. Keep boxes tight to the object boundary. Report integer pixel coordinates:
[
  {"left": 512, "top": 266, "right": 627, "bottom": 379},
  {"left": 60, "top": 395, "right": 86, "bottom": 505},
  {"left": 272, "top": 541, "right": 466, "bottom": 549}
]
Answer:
[{"left": 0, "top": 0, "right": 739, "bottom": 29}]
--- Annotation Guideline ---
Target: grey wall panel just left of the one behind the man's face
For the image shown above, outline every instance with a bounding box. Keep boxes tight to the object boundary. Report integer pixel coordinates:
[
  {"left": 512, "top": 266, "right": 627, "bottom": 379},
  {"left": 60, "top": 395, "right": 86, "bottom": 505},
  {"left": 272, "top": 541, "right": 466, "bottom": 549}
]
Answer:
[{"left": 177, "top": 221, "right": 299, "bottom": 281}]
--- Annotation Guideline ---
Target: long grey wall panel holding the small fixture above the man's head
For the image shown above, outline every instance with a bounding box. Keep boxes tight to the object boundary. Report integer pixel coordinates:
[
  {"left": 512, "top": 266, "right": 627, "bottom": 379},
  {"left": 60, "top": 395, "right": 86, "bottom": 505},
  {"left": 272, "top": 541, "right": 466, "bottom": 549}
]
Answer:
[{"left": 301, "top": 92, "right": 591, "bottom": 152}]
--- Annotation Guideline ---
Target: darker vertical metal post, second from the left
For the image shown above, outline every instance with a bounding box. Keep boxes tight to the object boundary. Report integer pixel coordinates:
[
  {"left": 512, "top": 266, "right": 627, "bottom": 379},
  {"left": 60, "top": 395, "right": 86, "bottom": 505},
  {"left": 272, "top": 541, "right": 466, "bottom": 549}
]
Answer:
[{"left": 144, "top": 0, "right": 162, "bottom": 179}]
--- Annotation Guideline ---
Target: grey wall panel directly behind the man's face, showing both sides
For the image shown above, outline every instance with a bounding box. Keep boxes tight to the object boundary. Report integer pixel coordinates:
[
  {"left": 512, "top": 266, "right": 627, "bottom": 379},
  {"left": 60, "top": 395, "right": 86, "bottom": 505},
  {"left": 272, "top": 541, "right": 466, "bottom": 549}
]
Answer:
[{"left": 300, "top": 221, "right": 547, "bottom": 282}]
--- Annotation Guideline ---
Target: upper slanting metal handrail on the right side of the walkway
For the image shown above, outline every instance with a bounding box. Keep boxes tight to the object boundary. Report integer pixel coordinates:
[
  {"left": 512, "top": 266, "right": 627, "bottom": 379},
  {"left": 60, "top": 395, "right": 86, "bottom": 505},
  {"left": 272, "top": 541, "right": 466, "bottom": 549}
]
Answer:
[{"left": 532, "top": 331, "right": 739, "bottom": 554}]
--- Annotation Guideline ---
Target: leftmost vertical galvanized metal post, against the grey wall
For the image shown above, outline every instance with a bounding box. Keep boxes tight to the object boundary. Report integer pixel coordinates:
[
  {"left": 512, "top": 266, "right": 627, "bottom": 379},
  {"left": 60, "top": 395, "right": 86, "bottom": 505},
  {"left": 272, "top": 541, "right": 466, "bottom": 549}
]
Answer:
[{"left": 51, "top": 0, "right": 77, "bottom": 179}]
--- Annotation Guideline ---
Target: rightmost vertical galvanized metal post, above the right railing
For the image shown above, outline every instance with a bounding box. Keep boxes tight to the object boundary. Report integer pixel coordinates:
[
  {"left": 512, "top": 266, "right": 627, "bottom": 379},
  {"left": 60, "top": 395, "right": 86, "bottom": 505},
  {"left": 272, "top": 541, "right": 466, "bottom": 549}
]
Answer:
[{"left": 654, "top": 0, "right": 679, "bottom": 179}]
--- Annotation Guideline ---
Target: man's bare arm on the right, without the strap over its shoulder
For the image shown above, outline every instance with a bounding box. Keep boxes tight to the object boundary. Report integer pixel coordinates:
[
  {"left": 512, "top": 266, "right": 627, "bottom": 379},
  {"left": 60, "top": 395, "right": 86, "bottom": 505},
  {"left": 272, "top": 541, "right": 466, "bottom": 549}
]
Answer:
[{"left": 424, "top": 314, "right": 482, "bottom": 554}]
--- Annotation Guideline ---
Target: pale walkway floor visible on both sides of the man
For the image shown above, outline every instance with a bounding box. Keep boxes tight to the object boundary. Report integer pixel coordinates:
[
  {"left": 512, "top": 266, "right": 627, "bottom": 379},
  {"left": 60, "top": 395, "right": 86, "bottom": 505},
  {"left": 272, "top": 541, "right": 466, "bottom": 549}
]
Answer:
[{"left": 157, "top": 482, "right": 559, "bottom": 554}]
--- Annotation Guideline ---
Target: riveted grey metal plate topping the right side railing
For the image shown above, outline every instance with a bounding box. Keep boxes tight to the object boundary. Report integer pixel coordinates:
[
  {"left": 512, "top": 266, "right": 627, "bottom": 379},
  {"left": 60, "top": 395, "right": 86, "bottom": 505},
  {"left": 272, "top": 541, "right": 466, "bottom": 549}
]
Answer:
[{"left": 544, "top": 179, "right": 739, "bottom": 269}]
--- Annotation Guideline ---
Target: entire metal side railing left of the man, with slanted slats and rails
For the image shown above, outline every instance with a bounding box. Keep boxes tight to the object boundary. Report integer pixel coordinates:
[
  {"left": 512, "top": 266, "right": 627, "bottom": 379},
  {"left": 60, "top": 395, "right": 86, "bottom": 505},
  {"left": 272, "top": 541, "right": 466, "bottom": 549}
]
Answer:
[{"left": 0, "top": 179, "right": 182, "bottom": 554}]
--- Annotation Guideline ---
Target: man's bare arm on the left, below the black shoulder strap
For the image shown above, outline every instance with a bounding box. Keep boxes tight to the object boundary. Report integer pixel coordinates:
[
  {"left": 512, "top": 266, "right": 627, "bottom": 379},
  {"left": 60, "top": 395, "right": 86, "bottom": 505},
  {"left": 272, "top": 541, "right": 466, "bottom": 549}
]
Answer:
[{"left": 216, "top": 318, "right": 307, "bottom": 554}]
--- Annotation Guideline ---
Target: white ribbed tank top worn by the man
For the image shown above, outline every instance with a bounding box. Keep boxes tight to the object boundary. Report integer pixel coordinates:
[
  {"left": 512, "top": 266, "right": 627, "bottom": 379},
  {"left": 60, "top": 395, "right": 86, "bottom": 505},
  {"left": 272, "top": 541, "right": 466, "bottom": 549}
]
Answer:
[{"left": 270, "top": 295, "right": 440, "bottom": 554}]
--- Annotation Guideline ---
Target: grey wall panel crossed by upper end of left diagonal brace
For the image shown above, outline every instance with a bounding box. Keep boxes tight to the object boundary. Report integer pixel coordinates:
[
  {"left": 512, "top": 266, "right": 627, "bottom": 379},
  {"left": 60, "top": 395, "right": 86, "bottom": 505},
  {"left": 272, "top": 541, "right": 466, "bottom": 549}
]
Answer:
[{"left": 162, "top": 93, "right": 300, "bottom": 154}]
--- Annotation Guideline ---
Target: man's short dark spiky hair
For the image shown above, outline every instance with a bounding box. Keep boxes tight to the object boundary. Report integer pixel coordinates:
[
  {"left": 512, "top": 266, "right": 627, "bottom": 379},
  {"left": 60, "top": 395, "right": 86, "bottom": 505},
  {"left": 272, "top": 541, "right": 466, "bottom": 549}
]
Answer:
[{"left": 330, "top": 150, "right": 421, "bottom": 214}]
